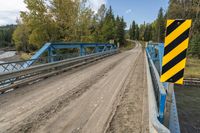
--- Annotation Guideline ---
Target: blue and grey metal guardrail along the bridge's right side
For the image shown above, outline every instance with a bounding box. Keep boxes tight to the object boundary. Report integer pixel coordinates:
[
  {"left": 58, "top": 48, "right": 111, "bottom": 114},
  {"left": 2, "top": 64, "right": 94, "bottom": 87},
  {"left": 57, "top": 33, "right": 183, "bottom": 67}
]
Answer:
[{"left": 146, "top": 43, "right": 180, "bottom": 133}]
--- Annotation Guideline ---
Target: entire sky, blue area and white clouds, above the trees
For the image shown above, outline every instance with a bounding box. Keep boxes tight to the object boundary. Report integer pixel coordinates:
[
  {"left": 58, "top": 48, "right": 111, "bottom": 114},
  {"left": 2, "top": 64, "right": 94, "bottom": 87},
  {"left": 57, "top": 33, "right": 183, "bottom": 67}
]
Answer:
[{"left": 0, "top": 0, "right": 168, "bottom": 28}]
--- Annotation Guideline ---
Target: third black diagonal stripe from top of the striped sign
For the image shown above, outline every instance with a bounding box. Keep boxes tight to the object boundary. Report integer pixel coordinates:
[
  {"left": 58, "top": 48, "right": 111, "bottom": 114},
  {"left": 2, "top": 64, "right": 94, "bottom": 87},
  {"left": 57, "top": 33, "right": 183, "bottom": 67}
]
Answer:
[{"left": 162, "top": 49, "right": 187, "bottom": 74}]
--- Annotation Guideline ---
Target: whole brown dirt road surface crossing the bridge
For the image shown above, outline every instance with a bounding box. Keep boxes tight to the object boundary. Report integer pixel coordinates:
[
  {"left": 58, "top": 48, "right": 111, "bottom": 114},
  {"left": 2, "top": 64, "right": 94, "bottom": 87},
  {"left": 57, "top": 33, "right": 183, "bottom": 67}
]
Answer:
[{"left": 0, "top": 44, "right": 148, "bottom": 133}]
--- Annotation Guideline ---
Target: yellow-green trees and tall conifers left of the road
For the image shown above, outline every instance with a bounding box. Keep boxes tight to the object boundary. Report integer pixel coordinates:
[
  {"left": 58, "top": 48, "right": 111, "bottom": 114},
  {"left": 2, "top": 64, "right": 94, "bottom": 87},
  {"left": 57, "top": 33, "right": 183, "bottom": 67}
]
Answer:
[{"left": 13, "top": 0, "right": 126, "bottom": 52}]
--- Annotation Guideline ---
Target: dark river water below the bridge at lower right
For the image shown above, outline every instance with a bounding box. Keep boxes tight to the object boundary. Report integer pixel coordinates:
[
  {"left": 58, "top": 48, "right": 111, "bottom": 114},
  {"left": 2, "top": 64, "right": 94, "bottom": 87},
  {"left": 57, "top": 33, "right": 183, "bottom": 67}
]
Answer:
[{"left": 175, "top": 86, "right": 200, "bottom": 133}]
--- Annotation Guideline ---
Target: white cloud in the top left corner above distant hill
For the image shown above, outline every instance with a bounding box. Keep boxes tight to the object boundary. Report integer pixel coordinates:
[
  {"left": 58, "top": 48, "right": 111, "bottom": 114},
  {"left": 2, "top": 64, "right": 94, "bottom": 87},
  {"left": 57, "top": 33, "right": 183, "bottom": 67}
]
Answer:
[{"left": 0, "top": 0, "right": 26, "bottom": 25}]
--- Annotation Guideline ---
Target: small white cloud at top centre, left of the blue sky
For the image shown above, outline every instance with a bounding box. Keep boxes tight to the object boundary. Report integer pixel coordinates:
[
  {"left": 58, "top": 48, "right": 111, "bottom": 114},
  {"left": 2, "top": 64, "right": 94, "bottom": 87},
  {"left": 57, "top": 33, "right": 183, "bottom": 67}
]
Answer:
[{"left": 88, "top": 0, "right": 107, "bottom": 13}]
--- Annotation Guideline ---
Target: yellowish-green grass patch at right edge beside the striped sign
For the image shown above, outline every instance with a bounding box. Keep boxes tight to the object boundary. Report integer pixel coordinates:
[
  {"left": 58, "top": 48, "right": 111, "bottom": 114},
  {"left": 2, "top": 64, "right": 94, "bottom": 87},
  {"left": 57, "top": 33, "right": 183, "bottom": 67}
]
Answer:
[{"left": 184, "top": 58, "right": 200, "bottom": 78}]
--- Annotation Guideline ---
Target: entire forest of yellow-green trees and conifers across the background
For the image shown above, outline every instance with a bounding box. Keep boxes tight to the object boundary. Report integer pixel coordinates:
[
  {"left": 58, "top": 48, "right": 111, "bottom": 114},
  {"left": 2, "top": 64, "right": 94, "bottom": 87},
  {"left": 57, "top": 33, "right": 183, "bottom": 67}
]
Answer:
[{"left": 0, "top": 0, "right": 200, "bottom": 58}]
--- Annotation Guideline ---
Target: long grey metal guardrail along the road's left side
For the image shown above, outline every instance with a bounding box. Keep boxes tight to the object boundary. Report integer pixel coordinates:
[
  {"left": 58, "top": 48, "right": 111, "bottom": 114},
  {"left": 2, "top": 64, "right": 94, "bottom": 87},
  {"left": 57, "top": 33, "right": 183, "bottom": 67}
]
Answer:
[{"left": 0, "top": 49, "right": 118, "bottom": 93}]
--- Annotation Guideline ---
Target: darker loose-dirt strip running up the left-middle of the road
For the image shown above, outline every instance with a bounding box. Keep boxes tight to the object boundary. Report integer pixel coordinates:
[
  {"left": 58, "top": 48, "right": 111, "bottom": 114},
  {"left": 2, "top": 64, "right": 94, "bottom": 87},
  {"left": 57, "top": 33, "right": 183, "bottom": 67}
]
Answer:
[{"left": 3, "top": 54, "right": 129, "bottom": 133}]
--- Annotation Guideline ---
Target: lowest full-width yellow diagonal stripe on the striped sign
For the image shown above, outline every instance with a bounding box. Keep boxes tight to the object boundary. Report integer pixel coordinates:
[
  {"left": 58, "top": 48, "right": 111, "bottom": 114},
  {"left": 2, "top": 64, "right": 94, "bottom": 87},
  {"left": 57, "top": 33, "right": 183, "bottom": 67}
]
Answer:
[{"left": 160, "top": 58, "right": 186, "bottom": 82}]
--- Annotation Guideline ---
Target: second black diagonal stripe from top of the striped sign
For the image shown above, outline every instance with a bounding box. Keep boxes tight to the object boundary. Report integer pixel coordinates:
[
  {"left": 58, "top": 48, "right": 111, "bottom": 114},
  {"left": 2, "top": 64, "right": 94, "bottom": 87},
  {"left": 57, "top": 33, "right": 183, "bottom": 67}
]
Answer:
[{"left": 164, "top": 28, "right": 190, "bottom": 56}]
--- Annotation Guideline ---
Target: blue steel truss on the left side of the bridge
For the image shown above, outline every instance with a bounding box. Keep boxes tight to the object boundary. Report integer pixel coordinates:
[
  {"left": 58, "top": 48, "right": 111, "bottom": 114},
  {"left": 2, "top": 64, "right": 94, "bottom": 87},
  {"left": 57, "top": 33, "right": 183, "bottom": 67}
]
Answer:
[{"left": 0, "top": 42, "right": 117, "bottom": 73}]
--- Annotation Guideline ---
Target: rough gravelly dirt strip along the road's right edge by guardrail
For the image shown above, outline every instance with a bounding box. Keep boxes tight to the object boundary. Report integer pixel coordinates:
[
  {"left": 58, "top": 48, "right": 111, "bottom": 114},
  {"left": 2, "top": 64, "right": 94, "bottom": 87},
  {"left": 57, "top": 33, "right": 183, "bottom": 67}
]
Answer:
[{"left": 106, "top": 42, "right": 148, "bottom": 133}]
